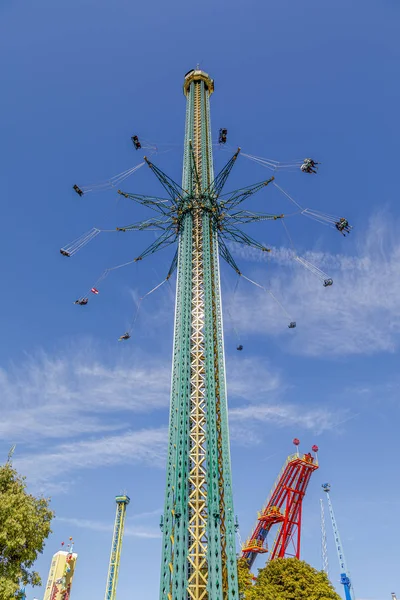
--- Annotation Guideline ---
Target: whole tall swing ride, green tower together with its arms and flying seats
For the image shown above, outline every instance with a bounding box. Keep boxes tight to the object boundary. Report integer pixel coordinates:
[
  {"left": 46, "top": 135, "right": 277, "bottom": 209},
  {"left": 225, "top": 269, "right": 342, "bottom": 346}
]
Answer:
[{"left": 60, "top": 69, "right": 351, "bottom": 600}]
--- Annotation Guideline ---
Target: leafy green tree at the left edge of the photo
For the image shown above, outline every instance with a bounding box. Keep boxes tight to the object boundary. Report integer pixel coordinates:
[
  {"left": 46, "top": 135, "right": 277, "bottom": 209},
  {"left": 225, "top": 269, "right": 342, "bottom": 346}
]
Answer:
[{"left": 0, "top": 462, "right": 53, "bottom": 600}]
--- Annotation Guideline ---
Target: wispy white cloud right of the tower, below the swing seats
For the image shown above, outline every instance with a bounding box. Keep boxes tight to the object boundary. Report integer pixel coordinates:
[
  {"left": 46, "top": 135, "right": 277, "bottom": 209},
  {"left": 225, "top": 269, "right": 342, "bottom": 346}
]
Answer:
[{"left": 227, "top": 215, "right": 400, "bottom": 356}]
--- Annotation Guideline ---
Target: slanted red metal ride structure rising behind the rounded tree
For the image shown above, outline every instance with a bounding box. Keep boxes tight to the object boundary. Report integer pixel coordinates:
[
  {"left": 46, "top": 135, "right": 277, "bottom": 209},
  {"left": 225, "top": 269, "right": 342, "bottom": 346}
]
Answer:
[{"left": 242, "top": 438, "right": 318, "bottom": 568}]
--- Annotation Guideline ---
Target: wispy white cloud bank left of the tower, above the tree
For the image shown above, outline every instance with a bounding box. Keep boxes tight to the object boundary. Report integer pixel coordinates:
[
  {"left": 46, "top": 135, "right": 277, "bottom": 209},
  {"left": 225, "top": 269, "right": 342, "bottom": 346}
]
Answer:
[{"left": 0, "top": 346, "right": 170, "bottom": 495}]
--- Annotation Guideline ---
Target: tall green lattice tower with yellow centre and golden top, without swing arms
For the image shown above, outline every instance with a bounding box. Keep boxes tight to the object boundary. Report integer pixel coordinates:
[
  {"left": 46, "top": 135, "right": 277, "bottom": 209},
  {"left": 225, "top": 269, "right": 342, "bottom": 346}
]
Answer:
[{"left": 160, "top": 70, "right": 238, "bottom": 600}]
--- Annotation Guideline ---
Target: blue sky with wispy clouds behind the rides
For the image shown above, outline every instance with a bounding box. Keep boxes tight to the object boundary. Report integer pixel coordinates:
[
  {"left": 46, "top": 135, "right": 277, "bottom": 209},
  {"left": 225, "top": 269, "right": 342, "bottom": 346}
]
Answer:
[{"left": 0, "top": 0, "right": 400, "bottom": 600}]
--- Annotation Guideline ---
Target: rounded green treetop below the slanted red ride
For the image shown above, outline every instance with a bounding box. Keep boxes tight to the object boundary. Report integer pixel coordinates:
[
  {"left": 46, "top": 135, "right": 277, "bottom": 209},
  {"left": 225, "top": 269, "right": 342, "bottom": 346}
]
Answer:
[{"left": 250, "top": 558, "right": 341, "bottom": 600}]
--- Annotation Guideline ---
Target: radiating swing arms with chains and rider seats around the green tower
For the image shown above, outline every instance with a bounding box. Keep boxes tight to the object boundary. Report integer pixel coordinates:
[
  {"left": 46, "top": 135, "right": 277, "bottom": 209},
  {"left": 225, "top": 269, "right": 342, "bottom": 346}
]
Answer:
[{"left": 60, "top": 128, "right": 352, "bottom": 344}]
